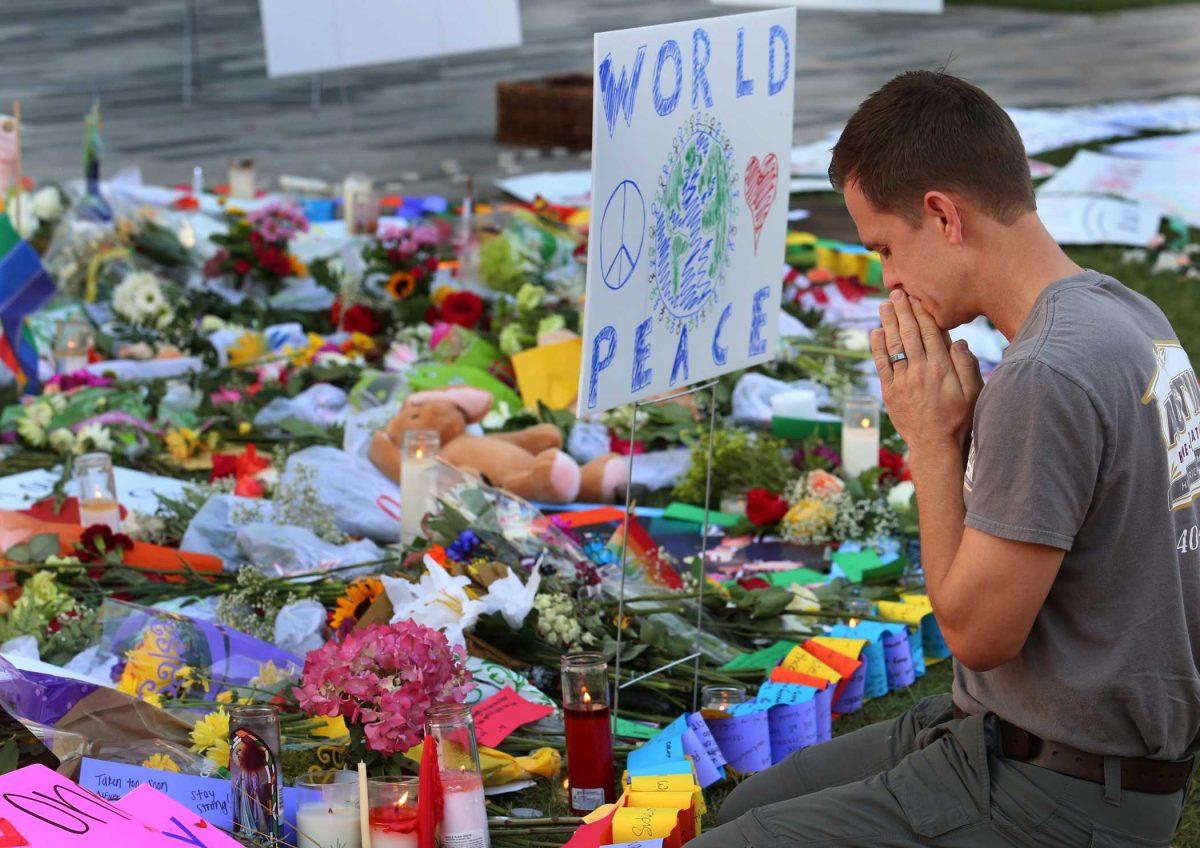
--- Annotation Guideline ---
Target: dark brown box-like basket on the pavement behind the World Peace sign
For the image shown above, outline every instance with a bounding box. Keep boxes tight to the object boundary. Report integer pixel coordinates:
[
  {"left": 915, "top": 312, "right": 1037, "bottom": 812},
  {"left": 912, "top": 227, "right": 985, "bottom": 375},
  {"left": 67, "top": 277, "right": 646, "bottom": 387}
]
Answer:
[{"left": 496, "top": 73, "right": 592, "bottom": 150}]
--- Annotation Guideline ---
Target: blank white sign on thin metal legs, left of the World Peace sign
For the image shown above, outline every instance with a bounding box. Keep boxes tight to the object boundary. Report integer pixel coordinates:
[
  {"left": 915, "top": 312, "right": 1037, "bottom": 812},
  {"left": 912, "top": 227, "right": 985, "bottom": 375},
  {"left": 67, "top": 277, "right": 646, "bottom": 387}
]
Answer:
[{"left": 259, "top": 0, "right": 521, "bottom": 77}]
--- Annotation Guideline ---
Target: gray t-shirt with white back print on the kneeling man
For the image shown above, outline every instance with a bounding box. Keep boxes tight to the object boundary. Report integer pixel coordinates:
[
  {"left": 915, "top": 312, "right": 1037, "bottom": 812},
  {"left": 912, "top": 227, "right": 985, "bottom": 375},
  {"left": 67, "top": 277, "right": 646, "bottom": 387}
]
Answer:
[{"left": 954, "top": 271, "right": 1200, "bottom": 759}]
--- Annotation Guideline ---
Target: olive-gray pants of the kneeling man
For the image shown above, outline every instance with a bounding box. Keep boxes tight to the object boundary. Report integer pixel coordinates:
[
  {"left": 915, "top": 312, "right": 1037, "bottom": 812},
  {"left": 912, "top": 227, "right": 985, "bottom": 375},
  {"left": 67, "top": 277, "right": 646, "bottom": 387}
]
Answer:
[{"left": 689, "top": 694, "right": 1183, "bottom": 848}]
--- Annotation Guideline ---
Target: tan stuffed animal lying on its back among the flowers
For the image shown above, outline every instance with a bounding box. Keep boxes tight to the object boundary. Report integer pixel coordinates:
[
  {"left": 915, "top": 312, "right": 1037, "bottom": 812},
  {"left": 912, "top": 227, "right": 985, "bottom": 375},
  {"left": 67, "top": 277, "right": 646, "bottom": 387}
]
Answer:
[{"left": 367, "top": 386, "right": 625, "bottom": 504}]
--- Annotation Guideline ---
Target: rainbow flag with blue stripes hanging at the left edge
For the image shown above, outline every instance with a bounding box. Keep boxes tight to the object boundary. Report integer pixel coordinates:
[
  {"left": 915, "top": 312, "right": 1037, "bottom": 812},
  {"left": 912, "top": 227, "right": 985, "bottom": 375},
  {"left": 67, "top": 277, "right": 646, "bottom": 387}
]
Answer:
[{"left": 0, "top": 212, "right": 58, "bottom": 395}]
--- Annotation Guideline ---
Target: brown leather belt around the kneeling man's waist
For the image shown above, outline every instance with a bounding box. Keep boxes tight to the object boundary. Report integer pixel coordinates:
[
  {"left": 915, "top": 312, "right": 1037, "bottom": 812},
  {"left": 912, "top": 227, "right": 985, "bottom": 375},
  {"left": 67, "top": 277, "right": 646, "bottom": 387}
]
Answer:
[{"left": 954, "top": 704, "right": 1193, "bottom": 795}]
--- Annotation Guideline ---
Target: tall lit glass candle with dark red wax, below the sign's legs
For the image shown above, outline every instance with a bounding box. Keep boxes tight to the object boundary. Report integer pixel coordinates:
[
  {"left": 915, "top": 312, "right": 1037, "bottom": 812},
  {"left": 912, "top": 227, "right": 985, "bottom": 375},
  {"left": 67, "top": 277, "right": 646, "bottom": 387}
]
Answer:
[{"left": 563, "top": 654, "right": 617, "bottom": 816}]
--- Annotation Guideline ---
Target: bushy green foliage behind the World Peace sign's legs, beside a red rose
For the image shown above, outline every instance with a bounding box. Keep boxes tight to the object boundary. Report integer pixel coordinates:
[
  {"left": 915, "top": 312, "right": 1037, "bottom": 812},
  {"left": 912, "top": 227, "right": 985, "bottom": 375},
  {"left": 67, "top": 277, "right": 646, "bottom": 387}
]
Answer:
[{"left": 674, "top": 427, "right": 797, "bottom": 504}]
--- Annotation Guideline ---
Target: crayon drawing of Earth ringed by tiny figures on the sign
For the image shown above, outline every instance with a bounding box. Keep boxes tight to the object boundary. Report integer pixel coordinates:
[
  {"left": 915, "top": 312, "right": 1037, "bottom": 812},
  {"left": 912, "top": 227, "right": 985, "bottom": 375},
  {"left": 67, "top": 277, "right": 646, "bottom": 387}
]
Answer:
[{"left": 649, "top": 115, "right": 738, "bottom": 333}]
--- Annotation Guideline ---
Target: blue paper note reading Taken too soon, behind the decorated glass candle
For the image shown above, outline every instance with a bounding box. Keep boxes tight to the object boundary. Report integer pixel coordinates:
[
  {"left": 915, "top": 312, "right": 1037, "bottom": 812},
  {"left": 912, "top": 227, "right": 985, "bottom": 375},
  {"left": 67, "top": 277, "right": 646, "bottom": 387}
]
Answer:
[{"left": 79, "top": 757, "right": 301, "bottom": 844}]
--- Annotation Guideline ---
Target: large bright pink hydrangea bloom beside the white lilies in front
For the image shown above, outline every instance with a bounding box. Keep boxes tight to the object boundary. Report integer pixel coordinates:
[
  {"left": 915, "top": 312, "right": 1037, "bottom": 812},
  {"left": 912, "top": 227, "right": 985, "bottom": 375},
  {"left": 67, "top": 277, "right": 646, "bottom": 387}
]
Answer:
[{"left": 295, "top": 620, "right": 474, "bottom": 756}]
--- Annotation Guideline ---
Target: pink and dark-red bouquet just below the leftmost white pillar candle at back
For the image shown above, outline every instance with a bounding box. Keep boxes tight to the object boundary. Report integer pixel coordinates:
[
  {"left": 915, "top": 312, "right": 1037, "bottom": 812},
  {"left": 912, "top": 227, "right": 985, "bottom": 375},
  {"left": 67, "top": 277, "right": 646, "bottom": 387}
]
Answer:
[{"left": 204, "top": 203, "right": 308, "bottom": 290}]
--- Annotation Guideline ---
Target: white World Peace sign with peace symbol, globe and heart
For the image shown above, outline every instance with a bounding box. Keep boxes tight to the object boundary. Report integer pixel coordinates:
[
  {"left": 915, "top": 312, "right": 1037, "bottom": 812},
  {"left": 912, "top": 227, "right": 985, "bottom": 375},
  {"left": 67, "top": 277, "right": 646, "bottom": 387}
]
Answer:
[{"left": 578, "top": 10, "right": 796, "bottom": 415}]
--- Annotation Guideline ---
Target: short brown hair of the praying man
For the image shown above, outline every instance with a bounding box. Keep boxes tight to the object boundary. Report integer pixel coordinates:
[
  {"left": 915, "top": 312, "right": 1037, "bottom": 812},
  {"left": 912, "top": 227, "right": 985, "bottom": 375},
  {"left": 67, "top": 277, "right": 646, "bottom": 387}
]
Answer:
[{"left": 829, "top": 71, "right": 1037, "bottom": 225}]
